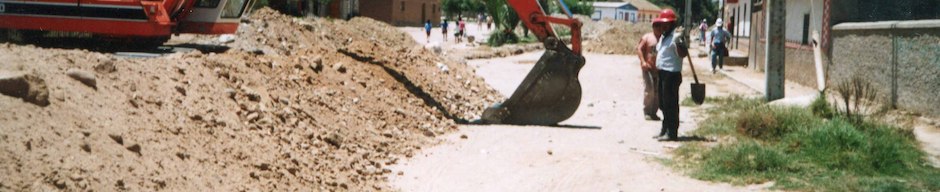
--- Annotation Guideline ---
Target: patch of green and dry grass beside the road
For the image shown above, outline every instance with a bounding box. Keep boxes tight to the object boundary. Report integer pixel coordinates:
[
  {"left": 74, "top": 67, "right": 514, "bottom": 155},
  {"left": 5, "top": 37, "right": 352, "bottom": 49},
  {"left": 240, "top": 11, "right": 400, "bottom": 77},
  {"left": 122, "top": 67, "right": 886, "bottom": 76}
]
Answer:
[{"left": 670, "top": 97, "right": 940, "bottom": 191}]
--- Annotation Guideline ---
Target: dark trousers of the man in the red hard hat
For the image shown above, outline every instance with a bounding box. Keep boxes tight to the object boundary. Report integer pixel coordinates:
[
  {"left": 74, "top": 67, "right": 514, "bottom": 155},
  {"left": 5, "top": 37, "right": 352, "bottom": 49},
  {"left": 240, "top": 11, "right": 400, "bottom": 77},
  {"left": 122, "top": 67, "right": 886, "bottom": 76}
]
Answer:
[{"left": 659, "top": 70, "right": 682, "bottom": 139}]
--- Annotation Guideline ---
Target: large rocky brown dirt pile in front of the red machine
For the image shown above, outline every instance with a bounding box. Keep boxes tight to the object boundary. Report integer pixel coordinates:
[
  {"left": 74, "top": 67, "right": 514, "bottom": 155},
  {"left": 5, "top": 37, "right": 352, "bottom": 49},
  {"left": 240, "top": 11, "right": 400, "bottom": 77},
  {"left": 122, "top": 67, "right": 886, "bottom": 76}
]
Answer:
[{"left": 0, "top": 9, "right": 500, "bottom": 191}]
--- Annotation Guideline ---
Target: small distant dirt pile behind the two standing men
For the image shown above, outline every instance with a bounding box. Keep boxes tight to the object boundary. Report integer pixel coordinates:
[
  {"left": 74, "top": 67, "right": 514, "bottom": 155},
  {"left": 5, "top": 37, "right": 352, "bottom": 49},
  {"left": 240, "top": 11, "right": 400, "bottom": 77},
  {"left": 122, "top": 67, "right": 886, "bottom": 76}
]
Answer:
[{"left": 584, "top": 19, "right": 653, "bottom": 55}]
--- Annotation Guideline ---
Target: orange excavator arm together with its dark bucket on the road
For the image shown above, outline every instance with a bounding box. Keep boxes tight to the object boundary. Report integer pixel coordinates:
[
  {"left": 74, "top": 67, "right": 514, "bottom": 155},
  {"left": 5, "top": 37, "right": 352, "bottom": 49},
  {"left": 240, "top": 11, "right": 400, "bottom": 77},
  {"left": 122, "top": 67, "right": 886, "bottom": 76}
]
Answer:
[{"left": 481, "top": 0, "right": 585, "bottom": 125}]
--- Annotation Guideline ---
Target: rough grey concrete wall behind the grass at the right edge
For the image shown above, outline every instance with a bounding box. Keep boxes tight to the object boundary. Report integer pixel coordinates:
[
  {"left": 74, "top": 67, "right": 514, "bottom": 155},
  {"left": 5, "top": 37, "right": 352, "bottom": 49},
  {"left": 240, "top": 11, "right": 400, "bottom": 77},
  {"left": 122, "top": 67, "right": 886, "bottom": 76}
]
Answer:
[{"left": 828, "top": 20, "right": 940, "bottom": 115}]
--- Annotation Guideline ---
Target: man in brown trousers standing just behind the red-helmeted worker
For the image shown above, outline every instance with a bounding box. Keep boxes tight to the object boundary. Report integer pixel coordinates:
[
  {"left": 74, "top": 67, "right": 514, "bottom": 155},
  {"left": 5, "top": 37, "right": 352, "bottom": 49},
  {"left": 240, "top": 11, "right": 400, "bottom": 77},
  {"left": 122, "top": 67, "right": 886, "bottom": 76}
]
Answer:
[{"left": 636, "top": 30, "right": 663, "bottom": 121}]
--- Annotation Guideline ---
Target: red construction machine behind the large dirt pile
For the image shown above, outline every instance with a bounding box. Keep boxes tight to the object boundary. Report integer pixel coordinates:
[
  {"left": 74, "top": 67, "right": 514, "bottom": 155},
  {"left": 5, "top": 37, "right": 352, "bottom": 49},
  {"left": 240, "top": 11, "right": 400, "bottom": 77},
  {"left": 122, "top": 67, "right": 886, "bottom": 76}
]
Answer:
[{"left": 0, "top": 0, "right": 250, "bottom": 44}]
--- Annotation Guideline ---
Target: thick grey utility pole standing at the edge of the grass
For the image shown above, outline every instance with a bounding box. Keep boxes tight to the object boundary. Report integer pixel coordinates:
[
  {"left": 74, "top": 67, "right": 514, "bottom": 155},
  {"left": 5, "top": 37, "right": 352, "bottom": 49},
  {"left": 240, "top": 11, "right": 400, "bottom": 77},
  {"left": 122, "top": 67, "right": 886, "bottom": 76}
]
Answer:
[{"left": 764, "top": 0, "right": 787, "bottom": 101}]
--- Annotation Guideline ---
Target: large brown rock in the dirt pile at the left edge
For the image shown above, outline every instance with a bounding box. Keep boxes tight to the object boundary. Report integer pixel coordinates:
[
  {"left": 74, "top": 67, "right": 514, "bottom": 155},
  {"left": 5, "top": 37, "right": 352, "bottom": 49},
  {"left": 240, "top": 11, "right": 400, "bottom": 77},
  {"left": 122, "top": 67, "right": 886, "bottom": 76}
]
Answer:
[{"left": 0, "top": 71, "right": 49, "bottom": 106}]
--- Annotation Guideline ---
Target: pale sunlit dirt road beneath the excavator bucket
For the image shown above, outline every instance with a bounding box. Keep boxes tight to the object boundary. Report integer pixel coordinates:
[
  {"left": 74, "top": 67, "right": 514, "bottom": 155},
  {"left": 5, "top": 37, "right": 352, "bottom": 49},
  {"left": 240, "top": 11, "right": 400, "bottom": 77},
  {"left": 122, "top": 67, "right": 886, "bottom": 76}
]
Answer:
[{"left": 390, "top": 52, "right": 761, "bottom": 191}]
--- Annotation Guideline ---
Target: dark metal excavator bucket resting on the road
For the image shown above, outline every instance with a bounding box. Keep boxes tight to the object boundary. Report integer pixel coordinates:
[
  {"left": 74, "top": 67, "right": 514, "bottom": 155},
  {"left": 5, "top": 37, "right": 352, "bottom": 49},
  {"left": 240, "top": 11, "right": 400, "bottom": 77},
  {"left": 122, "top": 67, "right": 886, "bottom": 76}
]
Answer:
[{"left": 482, "top": 37, "right": 584, "bottom": 125}]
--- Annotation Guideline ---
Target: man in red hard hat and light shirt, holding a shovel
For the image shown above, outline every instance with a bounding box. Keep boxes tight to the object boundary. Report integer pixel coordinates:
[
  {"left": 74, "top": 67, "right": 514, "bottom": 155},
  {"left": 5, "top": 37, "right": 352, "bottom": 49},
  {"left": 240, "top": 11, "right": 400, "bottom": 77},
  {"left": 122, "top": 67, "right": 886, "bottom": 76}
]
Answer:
[{"left": 653, "top": 9, "right": 689, "bottom": 141}]
